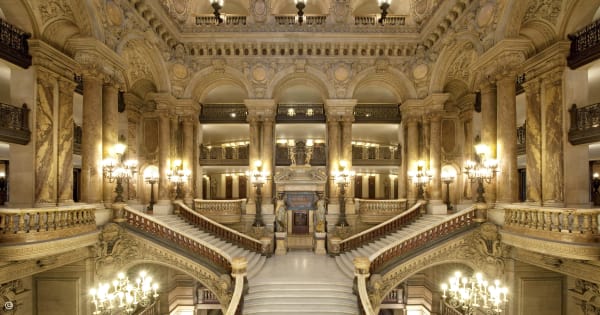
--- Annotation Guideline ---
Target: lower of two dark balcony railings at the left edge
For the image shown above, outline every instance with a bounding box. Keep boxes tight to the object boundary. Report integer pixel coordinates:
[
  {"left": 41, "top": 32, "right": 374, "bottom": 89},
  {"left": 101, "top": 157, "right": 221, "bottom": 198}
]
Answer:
[{"left": 0, "top": 103, "right": 31, "bottom": 144}]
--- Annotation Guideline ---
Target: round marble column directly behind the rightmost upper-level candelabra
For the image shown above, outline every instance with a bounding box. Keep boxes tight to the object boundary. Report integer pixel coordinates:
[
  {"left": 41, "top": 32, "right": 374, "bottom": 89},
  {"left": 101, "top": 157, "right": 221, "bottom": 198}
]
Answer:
[{"left": 481, "top": 82, "right": 496, "bottom": 204}]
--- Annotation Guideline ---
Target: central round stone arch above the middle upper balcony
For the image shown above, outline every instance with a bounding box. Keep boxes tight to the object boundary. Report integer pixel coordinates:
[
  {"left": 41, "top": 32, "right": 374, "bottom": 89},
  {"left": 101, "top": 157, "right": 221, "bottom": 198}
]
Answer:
[{"left": 265, "top": 66, "right": 335, "bottom": 100}]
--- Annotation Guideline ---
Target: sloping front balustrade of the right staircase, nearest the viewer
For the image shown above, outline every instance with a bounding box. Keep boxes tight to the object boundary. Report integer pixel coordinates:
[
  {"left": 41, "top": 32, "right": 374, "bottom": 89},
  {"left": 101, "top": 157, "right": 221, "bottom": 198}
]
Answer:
[{"left": 369, "top": 207, "right": 477, "bottom": 274}]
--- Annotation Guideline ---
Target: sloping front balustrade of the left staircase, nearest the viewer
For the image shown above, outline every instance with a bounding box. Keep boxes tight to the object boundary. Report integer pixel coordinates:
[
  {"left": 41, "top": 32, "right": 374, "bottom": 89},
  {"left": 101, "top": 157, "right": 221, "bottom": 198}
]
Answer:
[{"left": 123, "top": 206, "right": 232, "bottom": 274}]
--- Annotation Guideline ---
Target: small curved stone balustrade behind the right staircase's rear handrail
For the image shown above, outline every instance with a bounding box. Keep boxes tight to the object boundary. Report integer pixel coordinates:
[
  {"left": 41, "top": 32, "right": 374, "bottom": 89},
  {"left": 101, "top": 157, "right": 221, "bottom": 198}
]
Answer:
[{"left": 355, "top": 199, "right": 408, "bottom": 224}]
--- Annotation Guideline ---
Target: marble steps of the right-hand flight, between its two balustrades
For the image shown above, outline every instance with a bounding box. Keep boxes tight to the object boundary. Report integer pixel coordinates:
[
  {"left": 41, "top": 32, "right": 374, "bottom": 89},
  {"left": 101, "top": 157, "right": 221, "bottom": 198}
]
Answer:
[{"left": 335, "top": 214, "right": 448, "bottom": 279}]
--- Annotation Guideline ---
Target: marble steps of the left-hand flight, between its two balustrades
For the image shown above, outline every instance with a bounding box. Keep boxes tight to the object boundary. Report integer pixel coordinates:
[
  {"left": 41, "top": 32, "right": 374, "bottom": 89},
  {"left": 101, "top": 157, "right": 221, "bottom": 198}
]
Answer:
[{"left": 154, "top": 214, "right": 266, "bottom": 278}]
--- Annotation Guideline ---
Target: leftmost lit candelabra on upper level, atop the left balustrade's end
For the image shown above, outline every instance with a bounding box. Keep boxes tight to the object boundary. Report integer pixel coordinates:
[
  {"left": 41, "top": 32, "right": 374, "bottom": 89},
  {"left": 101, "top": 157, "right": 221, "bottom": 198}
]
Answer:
[{"left": 102, "top": 143, "right": 138, "bottom": 202}]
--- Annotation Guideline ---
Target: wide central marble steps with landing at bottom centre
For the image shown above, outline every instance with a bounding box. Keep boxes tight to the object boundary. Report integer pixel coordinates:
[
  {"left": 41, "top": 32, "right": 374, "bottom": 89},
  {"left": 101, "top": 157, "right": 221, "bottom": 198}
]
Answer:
[{"left": 243, "top": 251, "right": 358, "bottom": 315}]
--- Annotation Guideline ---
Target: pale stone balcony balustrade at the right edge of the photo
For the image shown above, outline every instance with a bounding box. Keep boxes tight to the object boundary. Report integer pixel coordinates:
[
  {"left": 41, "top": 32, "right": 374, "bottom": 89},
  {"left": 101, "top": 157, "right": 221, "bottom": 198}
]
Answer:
[{"left": 503, "top": 205, "right": 600, "bottom": 243}]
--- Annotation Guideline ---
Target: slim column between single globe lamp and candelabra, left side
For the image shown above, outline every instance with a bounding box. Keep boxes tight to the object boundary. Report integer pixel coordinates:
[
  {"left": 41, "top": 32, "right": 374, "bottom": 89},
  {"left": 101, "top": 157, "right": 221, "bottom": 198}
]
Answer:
[{"left": 157, "top": 110, "right": 171, "bottom": 202}]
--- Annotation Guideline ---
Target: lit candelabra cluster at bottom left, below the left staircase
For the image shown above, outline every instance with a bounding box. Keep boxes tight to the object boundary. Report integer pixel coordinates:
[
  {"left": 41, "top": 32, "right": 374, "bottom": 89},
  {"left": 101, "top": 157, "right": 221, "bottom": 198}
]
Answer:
[{"left": 90, "top": 271, "right": 158, "bottom": 315}]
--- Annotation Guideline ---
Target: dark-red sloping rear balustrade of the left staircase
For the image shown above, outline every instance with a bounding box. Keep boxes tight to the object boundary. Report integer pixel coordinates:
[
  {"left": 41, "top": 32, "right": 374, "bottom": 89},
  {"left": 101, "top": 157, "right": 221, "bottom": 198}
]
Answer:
[{"left": 174, "top": 201, "right": 267, "bottom": 254}]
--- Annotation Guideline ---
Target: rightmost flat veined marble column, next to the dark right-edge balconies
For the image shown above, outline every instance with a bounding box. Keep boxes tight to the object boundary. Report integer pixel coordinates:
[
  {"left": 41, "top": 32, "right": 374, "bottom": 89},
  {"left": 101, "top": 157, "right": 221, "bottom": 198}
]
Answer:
[{"left": 542, "top": 70, "right": 564, "bottom": 207}]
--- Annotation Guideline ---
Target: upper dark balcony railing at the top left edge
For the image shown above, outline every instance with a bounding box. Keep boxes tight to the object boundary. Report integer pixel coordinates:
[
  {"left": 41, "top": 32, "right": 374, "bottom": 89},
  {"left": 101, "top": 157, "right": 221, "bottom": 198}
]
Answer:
[{"left": 0, "top": 19, "right": 31, "bottom": 68}]
